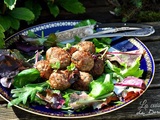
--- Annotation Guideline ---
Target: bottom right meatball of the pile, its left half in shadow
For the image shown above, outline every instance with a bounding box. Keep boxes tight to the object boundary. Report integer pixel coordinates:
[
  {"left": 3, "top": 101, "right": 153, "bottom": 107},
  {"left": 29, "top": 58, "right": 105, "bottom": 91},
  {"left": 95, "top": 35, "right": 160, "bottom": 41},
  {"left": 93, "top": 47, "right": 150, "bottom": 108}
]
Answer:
[{"left": 72, "top": 71, "right": 93, "bottom": 90}]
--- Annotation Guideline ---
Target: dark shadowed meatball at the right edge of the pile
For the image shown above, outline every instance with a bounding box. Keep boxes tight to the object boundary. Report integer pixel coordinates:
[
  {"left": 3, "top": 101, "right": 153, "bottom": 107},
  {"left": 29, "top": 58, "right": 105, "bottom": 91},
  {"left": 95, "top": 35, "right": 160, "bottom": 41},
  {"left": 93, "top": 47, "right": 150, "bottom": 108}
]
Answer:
[{"left": 90, "top": 58, "right": 104, "bottom": 77}]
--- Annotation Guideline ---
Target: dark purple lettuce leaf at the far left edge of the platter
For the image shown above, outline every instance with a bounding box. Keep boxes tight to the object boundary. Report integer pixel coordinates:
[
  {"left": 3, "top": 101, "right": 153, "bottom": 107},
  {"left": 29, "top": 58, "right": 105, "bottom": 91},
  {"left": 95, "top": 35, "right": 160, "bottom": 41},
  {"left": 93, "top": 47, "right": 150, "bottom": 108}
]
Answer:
[{"left": 0, "top": 54, "right": 25, "bottom": 88}]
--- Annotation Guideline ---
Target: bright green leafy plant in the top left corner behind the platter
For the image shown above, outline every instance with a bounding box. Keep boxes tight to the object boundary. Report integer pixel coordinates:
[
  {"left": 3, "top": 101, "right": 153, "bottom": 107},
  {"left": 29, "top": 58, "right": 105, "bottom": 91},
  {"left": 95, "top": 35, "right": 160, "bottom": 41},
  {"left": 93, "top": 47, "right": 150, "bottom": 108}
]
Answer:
[{"left": 0, "top": 0, "right": 85, "bottom": 48}]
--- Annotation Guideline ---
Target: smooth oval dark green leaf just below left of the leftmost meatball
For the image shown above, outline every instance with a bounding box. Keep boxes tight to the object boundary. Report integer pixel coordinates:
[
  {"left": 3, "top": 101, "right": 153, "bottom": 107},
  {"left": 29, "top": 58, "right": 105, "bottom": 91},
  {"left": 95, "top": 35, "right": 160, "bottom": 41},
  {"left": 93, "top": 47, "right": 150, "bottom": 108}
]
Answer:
[{"left": 13, "top": 68, "right": 40, "bottom": 88}]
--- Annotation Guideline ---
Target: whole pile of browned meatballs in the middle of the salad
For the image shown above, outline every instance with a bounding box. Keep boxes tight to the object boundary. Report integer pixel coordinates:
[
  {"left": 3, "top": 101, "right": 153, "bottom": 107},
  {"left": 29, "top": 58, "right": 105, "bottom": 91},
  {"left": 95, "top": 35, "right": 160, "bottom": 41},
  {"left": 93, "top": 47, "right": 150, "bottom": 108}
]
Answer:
[{"left": 35, "top": 41, "right": 104, "bottom": 91}]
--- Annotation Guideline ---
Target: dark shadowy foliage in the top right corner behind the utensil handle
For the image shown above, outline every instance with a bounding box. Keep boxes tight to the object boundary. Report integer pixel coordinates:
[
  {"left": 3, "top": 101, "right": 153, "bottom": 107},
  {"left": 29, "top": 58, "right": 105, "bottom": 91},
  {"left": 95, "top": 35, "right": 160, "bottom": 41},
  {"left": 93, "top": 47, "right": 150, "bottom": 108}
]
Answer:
[{"left": 108, "top": 0, "right": 160, "bottom": 22}]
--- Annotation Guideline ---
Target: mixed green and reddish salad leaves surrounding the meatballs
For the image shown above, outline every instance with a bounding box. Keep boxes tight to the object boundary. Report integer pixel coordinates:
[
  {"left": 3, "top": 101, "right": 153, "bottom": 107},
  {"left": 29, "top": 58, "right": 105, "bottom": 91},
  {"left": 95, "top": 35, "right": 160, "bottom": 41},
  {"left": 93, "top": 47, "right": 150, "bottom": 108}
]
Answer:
[{"left": 0, "top": 21, "right": 146, "bottom": 111}]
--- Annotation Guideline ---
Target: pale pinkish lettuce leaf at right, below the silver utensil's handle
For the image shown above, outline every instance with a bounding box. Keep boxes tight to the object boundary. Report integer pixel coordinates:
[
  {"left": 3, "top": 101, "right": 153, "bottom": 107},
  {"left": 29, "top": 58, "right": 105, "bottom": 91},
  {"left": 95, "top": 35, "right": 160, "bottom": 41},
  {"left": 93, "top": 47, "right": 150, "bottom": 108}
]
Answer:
[{"left": 106, "top": 50, "right": 145, "bottom": 66}]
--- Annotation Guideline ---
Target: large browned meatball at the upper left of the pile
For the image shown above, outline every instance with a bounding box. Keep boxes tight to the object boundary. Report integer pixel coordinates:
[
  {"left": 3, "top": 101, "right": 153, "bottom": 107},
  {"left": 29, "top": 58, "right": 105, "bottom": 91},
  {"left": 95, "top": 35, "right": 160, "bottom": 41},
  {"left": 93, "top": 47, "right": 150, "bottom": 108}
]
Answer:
[{"left": 46, "top": 47, "right": 71, "bottom": 69}]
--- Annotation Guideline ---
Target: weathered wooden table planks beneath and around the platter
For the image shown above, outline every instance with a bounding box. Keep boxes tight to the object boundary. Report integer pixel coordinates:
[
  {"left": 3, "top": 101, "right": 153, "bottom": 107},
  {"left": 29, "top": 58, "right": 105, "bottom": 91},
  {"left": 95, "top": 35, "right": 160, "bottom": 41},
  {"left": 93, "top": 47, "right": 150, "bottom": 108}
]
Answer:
[{"left": 0, "top": 22, "right": 160, "bottom": 120}]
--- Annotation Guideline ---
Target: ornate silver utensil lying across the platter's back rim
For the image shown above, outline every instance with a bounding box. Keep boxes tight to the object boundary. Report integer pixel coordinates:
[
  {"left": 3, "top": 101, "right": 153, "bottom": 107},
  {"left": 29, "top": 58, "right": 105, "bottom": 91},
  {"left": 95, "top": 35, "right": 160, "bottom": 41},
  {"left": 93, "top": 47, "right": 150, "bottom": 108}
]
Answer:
[{"left": 55, "top": 23, "right": 155, "bottom": 42}]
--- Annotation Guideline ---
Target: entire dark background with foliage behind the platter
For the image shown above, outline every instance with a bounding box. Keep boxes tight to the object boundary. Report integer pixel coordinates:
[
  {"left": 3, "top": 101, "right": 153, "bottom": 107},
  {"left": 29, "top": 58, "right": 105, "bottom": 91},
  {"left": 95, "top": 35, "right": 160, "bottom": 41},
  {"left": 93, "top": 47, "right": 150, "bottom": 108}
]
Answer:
[{"left": 0, "top": 0, "right": 160, "bottom": 48}]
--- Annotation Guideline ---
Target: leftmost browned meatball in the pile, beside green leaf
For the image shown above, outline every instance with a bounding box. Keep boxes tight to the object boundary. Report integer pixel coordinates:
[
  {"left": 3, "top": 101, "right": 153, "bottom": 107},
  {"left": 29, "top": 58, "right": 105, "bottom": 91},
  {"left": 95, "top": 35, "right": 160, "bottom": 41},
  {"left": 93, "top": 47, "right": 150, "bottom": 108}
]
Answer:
[{"left": 35, "top": 60, "right": 52, "bottom": 79}]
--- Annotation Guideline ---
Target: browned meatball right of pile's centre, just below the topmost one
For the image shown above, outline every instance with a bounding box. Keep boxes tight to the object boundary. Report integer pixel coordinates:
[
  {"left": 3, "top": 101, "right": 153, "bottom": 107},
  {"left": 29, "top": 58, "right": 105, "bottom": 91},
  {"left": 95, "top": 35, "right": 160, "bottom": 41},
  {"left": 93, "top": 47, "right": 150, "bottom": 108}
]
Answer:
[{"left": 71, "top": 51, "right": 94, "bottom": 72}]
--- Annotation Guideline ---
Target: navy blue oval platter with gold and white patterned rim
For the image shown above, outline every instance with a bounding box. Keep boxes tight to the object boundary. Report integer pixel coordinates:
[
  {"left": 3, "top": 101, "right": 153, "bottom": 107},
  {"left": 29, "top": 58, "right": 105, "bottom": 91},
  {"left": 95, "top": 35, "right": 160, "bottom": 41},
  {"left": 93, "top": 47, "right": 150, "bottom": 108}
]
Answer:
[{"left": 0, "top": 20, "right": 155, "bottom": 118}]
